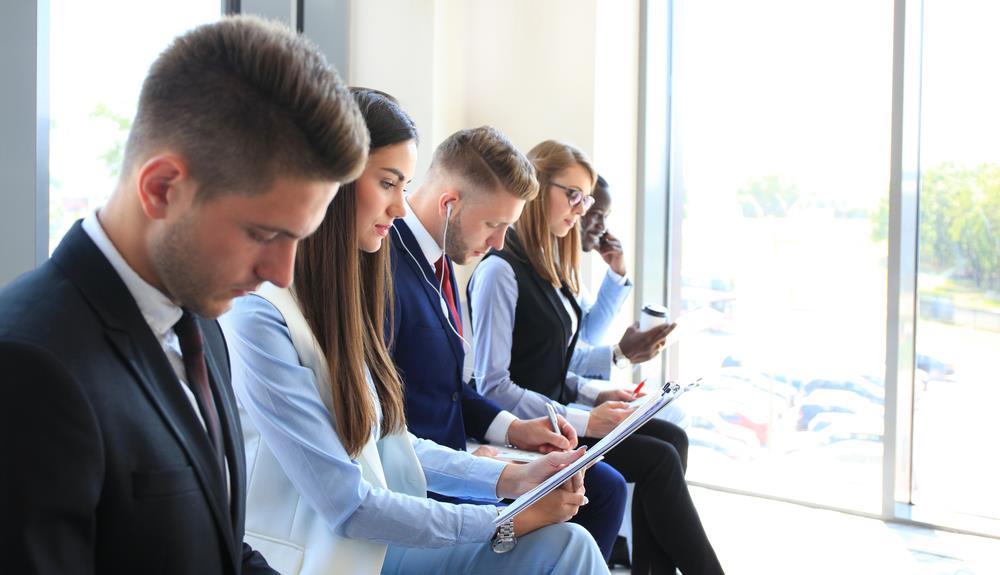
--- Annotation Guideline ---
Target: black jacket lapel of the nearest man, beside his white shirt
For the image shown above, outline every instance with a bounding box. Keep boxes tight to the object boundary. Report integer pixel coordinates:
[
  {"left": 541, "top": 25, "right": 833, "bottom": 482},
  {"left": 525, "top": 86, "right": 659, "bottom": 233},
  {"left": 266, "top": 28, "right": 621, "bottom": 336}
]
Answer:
[{"left": 52, "top": 222, "right": 243, "bottom": 562}]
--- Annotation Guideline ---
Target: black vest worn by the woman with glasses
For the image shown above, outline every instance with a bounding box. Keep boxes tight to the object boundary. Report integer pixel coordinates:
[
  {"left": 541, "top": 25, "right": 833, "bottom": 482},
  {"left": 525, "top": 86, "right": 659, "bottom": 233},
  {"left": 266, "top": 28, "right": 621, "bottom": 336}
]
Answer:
[{"left": 466, "top": 229, "right": 581, "bottom": 403}]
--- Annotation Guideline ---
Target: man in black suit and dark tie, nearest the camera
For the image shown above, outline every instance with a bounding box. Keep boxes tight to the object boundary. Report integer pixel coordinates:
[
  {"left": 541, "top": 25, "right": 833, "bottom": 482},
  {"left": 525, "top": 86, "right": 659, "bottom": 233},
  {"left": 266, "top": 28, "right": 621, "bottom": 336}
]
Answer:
[{"left": 0, "top": 17, "right": 368, "bottom": 575}]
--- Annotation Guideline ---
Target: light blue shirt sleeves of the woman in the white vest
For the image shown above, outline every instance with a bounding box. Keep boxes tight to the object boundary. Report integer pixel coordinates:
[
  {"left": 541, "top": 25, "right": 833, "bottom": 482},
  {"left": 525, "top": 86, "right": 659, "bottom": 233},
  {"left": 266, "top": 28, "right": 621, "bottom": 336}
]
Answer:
[{"left": 220, "top": 295, "right": 505, "bottom": 548}]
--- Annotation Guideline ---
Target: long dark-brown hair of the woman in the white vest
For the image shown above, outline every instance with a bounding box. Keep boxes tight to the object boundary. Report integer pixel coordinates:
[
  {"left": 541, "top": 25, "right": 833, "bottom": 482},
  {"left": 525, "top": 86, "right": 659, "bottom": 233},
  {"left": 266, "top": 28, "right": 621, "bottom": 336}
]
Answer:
[{"left": 292, "top": 88, "right": 417, "bottom": 457}]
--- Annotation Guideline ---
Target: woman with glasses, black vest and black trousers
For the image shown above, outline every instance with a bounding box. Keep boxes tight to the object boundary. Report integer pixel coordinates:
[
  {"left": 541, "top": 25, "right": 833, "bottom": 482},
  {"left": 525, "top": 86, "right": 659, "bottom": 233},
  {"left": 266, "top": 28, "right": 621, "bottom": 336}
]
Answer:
[{"left": 469, "top": 140, "right": 722, "bottom": 575}]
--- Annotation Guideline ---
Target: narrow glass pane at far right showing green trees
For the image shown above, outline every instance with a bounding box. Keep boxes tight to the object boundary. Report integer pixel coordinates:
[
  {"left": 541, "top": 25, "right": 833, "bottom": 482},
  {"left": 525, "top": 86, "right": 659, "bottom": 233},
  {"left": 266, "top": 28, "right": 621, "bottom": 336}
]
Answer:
[{"left": 912, "top": 0, "right": 1000, "bottom": 518}]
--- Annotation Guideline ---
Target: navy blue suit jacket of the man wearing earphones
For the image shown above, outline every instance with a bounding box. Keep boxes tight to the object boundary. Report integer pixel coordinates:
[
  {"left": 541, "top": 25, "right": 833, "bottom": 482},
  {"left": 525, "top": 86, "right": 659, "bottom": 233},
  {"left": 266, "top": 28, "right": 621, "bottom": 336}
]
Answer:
[{"left": 390, "top": 220, "right": 501, "bottom": 450}]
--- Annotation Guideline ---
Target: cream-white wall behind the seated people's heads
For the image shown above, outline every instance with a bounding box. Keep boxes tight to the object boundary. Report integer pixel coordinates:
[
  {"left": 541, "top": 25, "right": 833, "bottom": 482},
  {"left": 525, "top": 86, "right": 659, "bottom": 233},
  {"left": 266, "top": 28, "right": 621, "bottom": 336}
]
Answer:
[{"left": 349, "top": 0, "right": 639, "bottom": 328}]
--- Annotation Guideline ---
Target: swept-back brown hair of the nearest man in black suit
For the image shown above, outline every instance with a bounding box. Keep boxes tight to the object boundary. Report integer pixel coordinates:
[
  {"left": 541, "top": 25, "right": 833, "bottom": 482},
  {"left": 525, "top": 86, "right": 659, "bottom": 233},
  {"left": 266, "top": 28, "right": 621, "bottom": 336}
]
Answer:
[{"left": 122, "top": 16, "right": 368, "bottom": 201}]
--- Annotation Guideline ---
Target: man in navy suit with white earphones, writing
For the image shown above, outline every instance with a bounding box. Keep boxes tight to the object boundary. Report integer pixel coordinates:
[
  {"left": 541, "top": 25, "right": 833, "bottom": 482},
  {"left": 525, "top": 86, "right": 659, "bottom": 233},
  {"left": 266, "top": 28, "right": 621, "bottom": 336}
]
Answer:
[{"left": 390, "top": 126, "right": 625, "bottom": 558}]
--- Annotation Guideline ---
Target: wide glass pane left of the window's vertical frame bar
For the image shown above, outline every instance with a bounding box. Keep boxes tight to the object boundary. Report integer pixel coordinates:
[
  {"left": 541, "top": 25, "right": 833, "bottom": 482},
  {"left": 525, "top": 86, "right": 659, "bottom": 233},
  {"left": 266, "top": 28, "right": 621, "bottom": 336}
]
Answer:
[{"left": 672, "top": 0, "right": 892, "bottom": 513}]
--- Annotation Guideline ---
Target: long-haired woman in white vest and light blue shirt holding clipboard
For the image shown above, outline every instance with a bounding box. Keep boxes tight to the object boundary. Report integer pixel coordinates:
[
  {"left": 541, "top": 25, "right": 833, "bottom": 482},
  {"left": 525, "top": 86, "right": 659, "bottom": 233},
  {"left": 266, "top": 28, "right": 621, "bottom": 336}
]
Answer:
[{"left": 223, "top": 89, "right": 607, "bottom": 573}]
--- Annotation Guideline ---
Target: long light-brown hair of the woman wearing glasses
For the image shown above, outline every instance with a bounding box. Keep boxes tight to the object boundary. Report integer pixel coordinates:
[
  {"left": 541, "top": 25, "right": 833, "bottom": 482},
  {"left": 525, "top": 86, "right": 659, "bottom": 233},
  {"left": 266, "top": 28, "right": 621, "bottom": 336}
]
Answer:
[{"left": 514, "top": 140, "right": 596, "bottom": 293}]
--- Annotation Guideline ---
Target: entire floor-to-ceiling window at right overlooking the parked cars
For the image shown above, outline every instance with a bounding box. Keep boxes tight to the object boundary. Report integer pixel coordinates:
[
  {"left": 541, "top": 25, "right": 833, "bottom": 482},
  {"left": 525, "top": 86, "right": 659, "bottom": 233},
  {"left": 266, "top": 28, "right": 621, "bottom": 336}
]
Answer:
[{"left": 640, "top": 0, "right": 1000, "bottom": 535}]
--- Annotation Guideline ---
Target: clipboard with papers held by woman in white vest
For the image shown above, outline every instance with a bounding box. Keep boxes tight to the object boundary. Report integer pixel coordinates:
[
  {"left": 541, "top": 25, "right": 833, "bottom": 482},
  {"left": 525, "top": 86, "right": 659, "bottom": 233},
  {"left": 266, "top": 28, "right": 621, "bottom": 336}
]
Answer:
[{"left": 493, "top": 378, "right": 701, "bottom": 526}]
